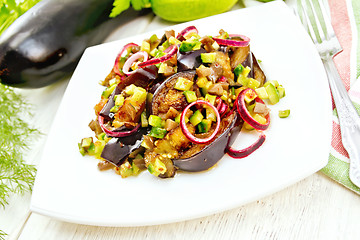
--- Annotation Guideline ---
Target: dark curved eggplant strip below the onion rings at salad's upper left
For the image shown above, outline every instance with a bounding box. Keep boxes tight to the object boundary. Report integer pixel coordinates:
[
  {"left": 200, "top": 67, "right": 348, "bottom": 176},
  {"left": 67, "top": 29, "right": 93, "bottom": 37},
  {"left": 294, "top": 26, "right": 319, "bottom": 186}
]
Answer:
[{"left": 100, "top": 65, "right": 158, "bottom": 121}]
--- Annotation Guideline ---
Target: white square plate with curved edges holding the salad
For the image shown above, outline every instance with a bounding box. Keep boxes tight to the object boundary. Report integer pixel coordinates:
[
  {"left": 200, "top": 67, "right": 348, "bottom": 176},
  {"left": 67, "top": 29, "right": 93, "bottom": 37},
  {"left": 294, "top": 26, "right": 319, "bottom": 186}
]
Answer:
[{"left": 31, "top": 1, "right": 332, "bottom": 226}]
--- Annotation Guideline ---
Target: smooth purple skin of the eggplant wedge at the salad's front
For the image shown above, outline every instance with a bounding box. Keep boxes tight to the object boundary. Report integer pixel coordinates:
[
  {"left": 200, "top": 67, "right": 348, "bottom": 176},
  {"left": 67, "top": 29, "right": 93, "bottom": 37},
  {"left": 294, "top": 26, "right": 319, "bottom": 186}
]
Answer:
[{"left": 173, "top": 112, "right": 241, "bottom": 172}]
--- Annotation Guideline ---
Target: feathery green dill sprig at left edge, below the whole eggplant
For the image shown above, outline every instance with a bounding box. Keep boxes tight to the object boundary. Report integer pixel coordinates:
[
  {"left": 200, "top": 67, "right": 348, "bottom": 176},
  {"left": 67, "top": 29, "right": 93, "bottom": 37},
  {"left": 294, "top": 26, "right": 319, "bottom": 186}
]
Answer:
[{"left": 0, "top": 84, "right": 40, "bottom": 207}]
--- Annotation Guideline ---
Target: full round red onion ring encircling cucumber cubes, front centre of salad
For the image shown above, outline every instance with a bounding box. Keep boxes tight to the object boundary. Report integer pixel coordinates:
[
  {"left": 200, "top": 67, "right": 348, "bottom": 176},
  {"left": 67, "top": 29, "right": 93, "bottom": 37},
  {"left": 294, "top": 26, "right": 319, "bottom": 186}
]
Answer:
[{"left": 180, "top": 100, "right": 221, "bottom": 144}]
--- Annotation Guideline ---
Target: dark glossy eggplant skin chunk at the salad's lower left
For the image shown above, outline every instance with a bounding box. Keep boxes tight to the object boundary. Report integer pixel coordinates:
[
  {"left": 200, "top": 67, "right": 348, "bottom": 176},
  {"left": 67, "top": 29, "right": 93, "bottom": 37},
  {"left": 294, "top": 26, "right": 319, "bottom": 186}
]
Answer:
[{"left": 101, "top": 128, "right": 149, "bottom": 166}]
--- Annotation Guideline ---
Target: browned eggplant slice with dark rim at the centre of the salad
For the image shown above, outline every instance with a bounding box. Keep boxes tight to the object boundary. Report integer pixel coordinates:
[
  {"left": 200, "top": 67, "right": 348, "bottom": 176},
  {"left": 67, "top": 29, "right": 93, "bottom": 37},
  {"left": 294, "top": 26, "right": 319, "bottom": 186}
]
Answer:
[{"left": 151, "top": 70, "right": 196, "bottom": 115}]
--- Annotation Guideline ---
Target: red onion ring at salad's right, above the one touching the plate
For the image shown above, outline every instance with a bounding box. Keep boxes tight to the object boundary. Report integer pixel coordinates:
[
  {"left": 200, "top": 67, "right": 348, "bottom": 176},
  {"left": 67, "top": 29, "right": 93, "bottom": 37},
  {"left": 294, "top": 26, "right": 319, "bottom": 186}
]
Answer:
[{"left": 236, "top": 88, "right": 270, "bottom": 130}]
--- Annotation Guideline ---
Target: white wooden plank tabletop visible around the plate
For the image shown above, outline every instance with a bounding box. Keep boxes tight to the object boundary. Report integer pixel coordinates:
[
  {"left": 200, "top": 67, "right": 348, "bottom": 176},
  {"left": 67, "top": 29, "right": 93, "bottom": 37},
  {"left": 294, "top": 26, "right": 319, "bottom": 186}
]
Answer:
[{"left": 0, "top": 1, "right": 360, "bottom": 240}]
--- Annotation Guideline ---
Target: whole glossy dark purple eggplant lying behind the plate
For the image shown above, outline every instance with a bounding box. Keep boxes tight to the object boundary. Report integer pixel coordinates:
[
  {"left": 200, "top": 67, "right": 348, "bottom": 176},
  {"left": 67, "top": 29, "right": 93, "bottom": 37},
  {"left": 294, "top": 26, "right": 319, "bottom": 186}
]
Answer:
[{"left": 0, "top": 0, "right": 136, "bottom": 88}]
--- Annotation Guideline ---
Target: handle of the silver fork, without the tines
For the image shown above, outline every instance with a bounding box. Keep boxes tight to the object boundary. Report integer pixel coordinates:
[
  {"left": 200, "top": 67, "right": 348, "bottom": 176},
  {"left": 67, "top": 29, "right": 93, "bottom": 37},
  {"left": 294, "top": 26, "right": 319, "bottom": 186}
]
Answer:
[{"left": 323, "top": 58, "right": 360, "bottom": 187}]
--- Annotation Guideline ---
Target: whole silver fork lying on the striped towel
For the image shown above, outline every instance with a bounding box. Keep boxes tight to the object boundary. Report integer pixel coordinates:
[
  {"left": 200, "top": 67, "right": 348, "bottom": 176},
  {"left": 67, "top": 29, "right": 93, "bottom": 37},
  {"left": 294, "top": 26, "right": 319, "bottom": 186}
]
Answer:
[{"left": 296, "top": 0, "right": 360, "bottom": 187}]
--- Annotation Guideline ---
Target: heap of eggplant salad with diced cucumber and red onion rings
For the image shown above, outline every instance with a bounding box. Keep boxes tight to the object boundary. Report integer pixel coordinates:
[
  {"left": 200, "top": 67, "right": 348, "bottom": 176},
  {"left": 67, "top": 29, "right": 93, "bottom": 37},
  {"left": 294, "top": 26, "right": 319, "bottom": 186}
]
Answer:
[{"left": 79, "top": 26, "right": 290, "bottom": 178}]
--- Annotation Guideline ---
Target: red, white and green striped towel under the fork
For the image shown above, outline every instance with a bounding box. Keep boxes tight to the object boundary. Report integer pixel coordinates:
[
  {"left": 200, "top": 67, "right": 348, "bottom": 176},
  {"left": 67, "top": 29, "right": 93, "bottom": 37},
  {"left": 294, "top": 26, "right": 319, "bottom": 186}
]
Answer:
[{"left": 321, "top": 0, "right": 360, "bottom": 194}]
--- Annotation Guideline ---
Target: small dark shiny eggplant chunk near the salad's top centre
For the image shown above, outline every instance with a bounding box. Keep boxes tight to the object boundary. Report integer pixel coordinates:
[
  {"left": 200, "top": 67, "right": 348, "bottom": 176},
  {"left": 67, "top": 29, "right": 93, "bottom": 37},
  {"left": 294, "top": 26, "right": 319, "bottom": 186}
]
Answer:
[{"left": 177, "top": 48, "right": 206, "bottom": 72}]
